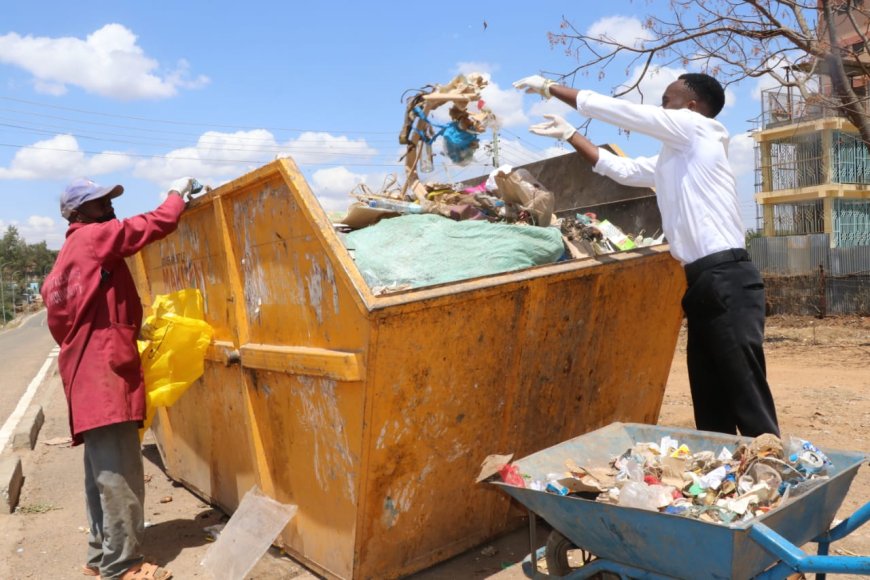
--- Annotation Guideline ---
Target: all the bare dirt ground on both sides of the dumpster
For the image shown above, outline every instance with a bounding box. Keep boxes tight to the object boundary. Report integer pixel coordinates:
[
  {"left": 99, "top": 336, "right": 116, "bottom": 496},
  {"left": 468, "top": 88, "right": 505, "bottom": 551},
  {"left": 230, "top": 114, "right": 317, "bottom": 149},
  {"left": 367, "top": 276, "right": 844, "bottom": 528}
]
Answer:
[{"left": 0, "top": 316, "right": 870, "bottom": 580}]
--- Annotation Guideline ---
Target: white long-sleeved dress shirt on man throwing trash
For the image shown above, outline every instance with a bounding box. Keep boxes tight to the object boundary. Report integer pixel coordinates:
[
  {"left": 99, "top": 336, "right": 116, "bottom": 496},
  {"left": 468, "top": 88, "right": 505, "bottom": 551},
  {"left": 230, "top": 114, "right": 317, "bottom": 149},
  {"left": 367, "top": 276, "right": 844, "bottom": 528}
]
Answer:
[{"left": 577, "top": 91, "right": 745, "bottom": 264}]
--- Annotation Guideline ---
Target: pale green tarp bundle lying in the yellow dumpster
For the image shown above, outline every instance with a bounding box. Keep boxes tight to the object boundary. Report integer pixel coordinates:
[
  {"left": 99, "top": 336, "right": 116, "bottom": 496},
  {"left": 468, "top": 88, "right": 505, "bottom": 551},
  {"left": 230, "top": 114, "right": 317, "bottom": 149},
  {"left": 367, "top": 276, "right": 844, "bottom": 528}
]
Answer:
[{"left": 346, "top": 214, "right": 565, "bottom": 288}]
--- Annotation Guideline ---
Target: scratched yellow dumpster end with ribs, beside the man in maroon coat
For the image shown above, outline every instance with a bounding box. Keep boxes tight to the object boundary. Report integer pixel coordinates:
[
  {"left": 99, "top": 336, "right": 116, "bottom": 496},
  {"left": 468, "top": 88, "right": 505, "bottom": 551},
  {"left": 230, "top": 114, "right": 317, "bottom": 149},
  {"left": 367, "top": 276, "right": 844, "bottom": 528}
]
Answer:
[{"left": 134, "top": 160, "right": 369, "bottom": 577}]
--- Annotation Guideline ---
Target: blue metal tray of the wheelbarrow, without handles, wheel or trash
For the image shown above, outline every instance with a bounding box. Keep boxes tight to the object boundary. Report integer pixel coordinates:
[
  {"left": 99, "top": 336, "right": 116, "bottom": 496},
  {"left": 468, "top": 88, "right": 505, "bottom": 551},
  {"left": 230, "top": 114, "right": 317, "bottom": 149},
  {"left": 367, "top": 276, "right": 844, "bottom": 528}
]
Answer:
[{"left": 494, "top": 423, "right": 866, "bottom": 578}]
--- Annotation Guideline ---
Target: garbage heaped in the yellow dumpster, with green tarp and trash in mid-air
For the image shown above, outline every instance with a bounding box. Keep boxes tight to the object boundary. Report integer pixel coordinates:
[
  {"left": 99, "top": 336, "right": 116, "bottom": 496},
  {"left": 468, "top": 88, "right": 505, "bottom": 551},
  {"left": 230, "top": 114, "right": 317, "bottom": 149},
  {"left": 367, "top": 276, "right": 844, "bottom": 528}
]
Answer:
[{"left": 335, "top": 73, "right": 663, "bottom": 294}]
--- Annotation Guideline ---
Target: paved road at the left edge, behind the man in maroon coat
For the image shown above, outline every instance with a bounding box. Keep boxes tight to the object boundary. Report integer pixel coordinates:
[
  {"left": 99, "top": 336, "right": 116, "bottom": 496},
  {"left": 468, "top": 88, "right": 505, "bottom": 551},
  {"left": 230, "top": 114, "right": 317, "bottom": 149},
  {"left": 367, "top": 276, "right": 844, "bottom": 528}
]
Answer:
[{"left": 0, "top": 310, "right": 56, "bottom": 450}]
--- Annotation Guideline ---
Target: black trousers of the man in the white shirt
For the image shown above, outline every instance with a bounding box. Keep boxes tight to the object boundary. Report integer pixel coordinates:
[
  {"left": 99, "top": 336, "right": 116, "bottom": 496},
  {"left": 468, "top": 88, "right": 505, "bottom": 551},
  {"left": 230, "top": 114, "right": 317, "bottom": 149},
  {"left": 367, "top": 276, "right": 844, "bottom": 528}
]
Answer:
[{"left": 683, "top": 250, "right": 779, "bottom": 437}]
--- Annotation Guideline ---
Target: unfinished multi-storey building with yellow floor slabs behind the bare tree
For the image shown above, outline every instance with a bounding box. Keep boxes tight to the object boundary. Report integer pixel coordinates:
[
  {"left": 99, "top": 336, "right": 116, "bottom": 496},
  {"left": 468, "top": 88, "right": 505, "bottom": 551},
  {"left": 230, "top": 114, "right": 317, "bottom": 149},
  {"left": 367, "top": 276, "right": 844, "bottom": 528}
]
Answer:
[{"left": 755, "top": 1, "right": 870, "bottom": 248}]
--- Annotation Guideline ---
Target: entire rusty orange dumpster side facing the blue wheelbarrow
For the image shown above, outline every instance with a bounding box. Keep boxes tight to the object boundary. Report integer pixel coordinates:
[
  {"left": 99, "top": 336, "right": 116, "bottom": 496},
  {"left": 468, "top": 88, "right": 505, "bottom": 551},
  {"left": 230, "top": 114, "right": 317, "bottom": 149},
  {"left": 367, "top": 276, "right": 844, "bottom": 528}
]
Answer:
[{"left": 358, "top": 253, "right": 684, "bottom": 578}]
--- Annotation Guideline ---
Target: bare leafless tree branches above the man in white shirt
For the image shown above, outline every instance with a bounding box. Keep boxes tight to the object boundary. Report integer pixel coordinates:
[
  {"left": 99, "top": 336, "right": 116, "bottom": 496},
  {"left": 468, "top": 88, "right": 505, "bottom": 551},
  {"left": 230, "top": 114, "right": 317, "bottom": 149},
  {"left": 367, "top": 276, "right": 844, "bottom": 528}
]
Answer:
[{"left": 550, "top": 0, "right": 870, "bottom": 145}]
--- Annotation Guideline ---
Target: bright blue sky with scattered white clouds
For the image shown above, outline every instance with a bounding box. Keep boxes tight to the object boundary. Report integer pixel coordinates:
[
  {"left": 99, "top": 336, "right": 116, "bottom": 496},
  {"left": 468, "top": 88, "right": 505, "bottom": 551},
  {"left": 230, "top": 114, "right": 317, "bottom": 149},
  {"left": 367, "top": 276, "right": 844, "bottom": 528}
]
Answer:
[{"left": 0, "top": 0, "right": 760, "bottom": 249}]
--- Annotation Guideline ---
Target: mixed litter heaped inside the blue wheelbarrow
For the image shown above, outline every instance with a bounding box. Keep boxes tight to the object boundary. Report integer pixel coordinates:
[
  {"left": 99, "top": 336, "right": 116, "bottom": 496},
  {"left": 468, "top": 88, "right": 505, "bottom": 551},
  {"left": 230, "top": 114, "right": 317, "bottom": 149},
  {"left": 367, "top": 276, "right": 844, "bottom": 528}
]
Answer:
[{"left": 498, "top": 434, "right": 832, "bottom": 525}]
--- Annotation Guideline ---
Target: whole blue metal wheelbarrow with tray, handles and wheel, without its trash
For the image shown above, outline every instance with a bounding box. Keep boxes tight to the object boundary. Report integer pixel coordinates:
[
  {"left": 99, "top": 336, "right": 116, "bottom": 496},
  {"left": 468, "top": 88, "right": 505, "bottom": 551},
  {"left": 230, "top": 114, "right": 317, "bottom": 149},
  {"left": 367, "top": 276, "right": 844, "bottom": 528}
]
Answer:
[{"left": 493, "top": 423, "right": 870, "bottom": 580}]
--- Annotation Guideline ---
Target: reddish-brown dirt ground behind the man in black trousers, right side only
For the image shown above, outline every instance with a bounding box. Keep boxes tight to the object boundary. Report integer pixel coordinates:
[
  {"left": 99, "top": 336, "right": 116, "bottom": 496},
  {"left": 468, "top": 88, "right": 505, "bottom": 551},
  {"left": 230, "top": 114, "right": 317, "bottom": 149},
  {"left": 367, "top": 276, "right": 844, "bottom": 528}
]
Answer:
[{"left": 659, "top": 316, "right": 870, "bottom": 555}]
